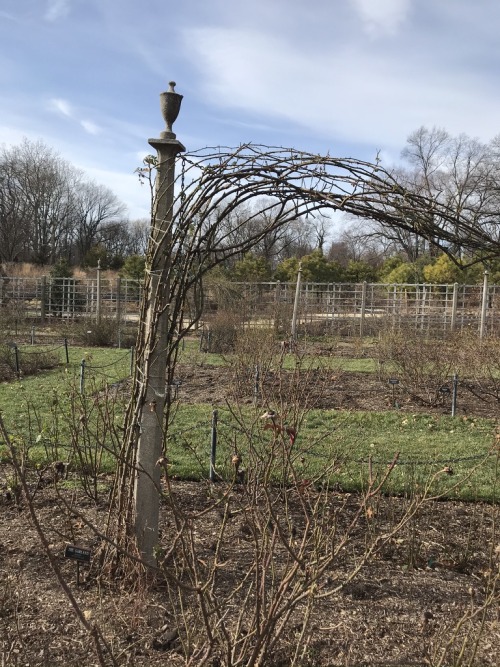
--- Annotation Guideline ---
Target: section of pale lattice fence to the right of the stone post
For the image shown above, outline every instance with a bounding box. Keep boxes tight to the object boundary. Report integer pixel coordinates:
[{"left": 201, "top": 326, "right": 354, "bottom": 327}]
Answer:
[{"left": 204, "top": 275, "right": 500, "bottom": 337}]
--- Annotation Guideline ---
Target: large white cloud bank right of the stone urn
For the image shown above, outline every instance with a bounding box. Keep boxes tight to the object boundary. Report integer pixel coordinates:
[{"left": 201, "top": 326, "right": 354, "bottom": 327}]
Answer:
[{"left": 185, "top": 22, "right": 500, "bottom": 150}]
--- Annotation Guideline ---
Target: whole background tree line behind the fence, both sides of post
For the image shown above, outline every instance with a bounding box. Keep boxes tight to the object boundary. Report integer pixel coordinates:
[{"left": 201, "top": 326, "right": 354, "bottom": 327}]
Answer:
[{"left": 0, "top": 127, "right": 500, "bottom": 283}]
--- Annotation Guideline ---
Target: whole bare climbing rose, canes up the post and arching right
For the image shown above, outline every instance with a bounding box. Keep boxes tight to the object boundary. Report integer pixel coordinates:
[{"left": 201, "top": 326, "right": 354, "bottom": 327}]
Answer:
[{"left": 114, "top": 144, "right": 499, "bottom": 560}]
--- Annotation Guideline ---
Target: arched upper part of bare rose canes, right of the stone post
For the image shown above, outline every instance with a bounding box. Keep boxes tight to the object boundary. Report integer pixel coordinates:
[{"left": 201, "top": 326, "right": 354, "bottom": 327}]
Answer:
[{"left": 155, "top": 144, "right": 500, "bottom": 354}]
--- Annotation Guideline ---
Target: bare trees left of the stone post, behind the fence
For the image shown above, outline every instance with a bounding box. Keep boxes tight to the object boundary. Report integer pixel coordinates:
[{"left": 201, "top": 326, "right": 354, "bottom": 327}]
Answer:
[{"left": 0, "top": 139, "right": 149, "bottom": 268}]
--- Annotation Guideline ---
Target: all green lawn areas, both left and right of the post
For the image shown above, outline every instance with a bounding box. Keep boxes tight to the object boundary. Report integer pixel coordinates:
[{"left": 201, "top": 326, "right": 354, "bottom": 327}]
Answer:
[{"left": 0, "top": 343, "right": 497, "bottom": 500}]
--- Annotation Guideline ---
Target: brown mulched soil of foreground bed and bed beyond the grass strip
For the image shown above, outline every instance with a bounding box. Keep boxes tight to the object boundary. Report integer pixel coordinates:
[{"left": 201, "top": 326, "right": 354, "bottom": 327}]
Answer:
[{"left": 0, "top": 358, "right": 500, "bottom": 667}]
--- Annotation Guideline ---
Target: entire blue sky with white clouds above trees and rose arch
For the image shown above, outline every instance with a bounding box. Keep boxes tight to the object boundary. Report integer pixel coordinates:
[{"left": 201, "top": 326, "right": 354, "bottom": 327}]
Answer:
[{"left": 0, "top": 0, "right": 500, "bottom": 220}]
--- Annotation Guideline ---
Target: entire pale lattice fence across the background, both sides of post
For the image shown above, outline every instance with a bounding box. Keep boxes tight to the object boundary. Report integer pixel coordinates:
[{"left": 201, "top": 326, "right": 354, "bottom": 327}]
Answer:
[{"left": 0, "top": 271, "right": 500, "bottom": 336}]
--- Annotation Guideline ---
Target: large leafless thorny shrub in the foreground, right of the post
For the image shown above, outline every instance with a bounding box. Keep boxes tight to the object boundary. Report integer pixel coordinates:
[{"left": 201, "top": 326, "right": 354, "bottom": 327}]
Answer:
[{"left": 157, "top": 412, "right": 456, "bottom": 665}]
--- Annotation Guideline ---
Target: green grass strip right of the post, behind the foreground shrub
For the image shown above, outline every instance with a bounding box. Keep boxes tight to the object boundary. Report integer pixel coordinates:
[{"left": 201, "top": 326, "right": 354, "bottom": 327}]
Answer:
[{"left": 163, "top": 405, "right": 498, "bottom": 501}]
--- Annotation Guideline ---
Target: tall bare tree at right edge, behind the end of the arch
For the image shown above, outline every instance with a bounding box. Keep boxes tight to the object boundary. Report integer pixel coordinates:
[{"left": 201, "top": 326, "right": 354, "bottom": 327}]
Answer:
[{"left": 338, "top": 127, "right": 500, "bottom": 264}]
